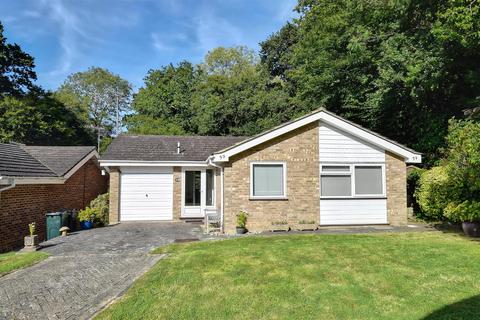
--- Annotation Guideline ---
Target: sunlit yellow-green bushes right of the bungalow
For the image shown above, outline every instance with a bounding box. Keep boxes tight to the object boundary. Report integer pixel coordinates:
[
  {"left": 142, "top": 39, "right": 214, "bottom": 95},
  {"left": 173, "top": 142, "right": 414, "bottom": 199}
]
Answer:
[{"left": 417, "top": 120, "right": 480, "bottom": 221}]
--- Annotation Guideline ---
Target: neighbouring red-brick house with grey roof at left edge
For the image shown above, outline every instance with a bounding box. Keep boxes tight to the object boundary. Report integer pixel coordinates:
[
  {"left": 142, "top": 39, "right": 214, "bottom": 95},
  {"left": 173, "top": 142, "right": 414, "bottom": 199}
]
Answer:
[{"left": 0, "top": 144, "right": 108, "bottom": 251}]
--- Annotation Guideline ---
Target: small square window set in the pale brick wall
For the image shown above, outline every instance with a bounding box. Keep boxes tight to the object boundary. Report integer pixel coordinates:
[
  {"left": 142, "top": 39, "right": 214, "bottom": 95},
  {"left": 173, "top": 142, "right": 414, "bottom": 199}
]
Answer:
[{"left": 250, "top": 163, "right": 286, "bottom": 198}]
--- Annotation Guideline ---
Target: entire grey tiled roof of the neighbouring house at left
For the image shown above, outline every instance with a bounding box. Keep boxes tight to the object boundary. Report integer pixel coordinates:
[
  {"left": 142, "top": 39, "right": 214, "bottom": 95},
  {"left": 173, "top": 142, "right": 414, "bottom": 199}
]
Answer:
[{"left": 0, "top": 143, "right": 95, "bottom": 178}]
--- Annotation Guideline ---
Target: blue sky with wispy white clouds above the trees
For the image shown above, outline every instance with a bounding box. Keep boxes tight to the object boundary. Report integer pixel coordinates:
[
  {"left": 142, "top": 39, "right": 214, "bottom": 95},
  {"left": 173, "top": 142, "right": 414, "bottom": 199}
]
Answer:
[{"left": 0, "top": 0, "right": 297, "bottom": 91}]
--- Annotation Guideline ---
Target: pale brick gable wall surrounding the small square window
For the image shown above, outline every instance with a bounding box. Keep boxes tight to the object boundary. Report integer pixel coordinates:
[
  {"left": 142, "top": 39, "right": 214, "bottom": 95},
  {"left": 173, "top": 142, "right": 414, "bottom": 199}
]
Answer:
[{"left": 224, "top": 123, "right": 320, "bottom": 233}]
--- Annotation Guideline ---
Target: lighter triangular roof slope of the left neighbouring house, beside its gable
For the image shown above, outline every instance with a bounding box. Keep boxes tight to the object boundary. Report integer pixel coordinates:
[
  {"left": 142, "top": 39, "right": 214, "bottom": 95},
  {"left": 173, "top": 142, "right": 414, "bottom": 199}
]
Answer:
[{"left": 22, "top": 146, "right": 95, "bottom": 176}]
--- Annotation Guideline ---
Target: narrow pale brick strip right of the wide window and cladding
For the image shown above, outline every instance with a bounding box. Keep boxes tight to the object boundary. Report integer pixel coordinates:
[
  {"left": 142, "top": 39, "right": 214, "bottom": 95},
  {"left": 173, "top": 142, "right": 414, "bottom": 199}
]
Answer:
[{"left": 385, "top": 152, "right": 407, "bottom": 226}]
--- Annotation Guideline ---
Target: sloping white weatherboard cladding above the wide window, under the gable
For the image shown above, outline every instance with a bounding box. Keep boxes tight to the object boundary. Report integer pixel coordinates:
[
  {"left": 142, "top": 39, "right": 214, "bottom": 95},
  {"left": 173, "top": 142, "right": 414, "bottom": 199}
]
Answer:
[{"left": 319, "top": 122, "right": 385, "bottom": 163}]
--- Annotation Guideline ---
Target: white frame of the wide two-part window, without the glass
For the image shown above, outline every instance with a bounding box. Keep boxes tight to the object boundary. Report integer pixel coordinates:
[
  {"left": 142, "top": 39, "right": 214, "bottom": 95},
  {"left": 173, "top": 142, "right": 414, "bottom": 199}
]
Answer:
[{"left": 320, "top": 163, "right": 387, "bottom": 199}]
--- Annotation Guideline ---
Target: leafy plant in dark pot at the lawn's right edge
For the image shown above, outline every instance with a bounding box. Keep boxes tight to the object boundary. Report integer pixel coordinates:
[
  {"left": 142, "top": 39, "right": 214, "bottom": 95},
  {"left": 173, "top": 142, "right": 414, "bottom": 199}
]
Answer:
[{"left": 444, "top": 200, "right": 480, "bottom": 237}]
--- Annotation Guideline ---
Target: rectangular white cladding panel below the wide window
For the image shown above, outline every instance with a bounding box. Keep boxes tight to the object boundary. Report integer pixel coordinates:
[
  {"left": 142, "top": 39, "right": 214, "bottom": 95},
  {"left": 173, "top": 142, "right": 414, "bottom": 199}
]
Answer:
[{"left": 320, "top": 199, "right": 387, "bottom": 226}]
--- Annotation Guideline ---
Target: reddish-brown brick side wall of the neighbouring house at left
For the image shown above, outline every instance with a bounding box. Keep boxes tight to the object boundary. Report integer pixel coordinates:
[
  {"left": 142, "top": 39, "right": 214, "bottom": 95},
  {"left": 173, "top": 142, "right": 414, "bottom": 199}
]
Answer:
[{"left": 0, "top": 160, "right": 108, "bottom": 251}]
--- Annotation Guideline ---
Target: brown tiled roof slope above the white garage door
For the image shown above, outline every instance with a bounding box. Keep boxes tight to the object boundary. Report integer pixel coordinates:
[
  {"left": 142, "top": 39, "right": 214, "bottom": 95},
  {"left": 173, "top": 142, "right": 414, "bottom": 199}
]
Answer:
[{"left": 101, "top": 135, "right": 246, "bottom": 161}]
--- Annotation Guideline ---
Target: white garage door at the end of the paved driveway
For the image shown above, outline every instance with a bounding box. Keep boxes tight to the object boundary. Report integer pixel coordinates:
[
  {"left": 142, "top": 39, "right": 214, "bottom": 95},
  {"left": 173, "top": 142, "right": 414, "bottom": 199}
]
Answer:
[{"left": 120, "top": 167, "right": 173, "bottom": 221}]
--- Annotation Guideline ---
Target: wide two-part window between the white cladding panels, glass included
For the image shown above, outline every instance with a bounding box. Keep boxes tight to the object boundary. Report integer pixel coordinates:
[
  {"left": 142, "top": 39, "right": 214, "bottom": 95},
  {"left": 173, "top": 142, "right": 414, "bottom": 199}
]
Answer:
[{"left": 320, "top": 165, "right": 385, "bottom": 197}]
